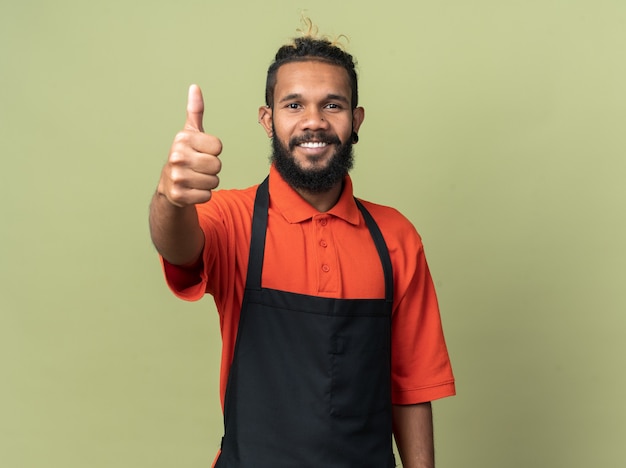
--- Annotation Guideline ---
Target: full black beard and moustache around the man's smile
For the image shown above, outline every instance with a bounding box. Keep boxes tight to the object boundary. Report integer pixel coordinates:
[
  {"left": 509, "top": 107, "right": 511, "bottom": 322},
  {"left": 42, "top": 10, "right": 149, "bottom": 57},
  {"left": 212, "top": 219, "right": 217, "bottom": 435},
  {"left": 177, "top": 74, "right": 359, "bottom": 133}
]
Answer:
[{"left": 271, "top": 132, "right": 354, "bottom": 193}]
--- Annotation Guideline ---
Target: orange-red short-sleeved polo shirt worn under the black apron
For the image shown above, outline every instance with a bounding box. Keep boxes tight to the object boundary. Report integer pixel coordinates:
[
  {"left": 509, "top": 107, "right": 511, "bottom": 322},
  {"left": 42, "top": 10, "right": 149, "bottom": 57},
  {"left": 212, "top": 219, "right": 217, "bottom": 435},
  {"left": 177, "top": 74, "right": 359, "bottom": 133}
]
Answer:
[{"left": 163, "top": 166, "right": 455, "bottom": 407}]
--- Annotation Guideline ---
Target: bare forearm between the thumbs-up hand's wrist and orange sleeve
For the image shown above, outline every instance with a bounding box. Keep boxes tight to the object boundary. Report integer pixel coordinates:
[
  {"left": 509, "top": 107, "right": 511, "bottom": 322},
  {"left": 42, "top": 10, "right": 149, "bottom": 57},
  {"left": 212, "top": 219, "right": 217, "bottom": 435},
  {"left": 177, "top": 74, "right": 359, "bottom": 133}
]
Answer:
[{"left": 150, "top": 192, "right": 204, "bottom": 265}]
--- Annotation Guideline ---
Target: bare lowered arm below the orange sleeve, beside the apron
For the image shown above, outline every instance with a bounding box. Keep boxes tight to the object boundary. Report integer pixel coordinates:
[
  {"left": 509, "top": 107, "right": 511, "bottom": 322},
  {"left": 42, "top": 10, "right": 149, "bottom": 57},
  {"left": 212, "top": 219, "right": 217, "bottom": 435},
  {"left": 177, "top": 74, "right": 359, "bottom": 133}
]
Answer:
[{"left": 392, "top": 402, "right": 435, "bottom": 468}]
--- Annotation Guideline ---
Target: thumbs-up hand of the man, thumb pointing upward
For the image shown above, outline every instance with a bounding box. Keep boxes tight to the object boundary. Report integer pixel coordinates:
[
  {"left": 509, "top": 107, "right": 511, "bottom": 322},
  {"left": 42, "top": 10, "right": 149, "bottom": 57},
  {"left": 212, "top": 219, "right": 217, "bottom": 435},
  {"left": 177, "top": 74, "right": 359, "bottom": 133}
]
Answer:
[{"left": 157, "top": 85, "right": 222, "bottom": 207}]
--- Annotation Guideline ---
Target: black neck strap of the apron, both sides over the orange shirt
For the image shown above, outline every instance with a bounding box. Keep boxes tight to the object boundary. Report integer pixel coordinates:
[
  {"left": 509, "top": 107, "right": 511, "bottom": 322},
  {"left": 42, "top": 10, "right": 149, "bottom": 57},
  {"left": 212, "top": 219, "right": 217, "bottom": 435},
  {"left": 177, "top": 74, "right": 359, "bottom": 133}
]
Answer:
[{"left": 246, "top": 176, "right": 393, "bottom": 304}]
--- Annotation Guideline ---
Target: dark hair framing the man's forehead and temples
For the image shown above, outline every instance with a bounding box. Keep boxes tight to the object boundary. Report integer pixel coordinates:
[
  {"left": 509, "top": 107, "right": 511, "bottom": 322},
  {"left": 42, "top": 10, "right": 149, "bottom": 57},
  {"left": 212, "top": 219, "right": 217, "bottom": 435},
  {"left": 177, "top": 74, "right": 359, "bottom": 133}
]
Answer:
[{"left": 265, "top": 36, "right": 359, "bottom": 108}]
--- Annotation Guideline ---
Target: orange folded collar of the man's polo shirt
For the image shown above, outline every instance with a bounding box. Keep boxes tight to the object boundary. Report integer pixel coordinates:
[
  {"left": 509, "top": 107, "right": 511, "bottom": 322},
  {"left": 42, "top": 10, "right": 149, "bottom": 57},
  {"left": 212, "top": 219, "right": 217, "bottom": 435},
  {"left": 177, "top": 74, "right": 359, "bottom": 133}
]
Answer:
[{"left": 269, "top": 164, "right": 360, "bottom": 225}]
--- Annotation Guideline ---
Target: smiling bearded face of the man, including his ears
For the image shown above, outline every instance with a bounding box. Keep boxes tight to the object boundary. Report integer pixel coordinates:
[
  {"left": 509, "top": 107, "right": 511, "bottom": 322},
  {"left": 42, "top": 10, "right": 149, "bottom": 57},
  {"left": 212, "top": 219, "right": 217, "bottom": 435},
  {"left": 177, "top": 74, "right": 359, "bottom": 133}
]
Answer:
[{"left": 259, "top": 61, "right": 364, "bottom": 192}]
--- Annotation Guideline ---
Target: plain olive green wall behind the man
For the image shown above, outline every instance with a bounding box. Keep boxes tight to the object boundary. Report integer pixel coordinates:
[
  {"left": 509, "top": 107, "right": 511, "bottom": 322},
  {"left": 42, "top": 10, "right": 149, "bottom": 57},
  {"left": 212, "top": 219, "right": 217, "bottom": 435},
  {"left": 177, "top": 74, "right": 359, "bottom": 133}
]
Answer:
[{"left": 0, "top": 0, "right": 626, "bottom": 468}]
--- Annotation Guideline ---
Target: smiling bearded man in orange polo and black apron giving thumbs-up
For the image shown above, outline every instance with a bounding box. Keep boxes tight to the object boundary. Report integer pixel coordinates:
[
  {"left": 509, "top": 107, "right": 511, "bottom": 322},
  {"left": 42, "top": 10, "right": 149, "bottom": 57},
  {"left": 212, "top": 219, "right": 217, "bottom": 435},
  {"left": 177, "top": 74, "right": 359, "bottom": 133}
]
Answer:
[{"left": 150, "top": 31, "right": 455, "bottom": 468}]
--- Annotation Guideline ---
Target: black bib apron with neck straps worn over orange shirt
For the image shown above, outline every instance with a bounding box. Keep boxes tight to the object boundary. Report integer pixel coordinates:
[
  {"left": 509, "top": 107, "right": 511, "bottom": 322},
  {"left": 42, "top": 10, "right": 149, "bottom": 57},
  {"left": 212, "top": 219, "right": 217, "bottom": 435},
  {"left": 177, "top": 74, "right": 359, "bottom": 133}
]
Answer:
[{"left": 215, "top": 179, "right": 395, "bottom": 468}]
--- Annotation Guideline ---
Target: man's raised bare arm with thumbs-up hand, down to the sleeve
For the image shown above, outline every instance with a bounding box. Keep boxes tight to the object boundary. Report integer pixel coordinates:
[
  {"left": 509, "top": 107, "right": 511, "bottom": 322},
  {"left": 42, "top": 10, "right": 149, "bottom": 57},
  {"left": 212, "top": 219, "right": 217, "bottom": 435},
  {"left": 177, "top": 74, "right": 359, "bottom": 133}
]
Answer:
[{"left": 150, "top": 85, "right": 222, "bottom": 265}]
